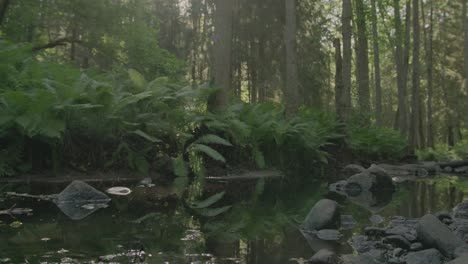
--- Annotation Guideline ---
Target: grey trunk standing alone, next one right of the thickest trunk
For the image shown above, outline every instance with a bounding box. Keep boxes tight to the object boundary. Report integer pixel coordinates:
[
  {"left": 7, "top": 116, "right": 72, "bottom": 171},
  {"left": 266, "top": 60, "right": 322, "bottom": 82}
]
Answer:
[{"left": 284, "top": 0, "right": 299, "bottom": 116}]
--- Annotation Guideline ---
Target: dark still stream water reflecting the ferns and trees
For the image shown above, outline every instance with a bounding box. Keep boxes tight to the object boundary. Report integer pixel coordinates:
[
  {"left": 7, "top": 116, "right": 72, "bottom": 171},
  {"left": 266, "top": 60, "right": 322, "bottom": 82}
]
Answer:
[{"left": 0, "top": 176, "right": 468, "bottom": 264}]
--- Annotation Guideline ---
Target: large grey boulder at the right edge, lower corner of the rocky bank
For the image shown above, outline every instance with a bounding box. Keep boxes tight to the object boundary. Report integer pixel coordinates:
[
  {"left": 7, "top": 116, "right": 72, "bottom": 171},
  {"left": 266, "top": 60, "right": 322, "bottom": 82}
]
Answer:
[{"left": 416, "top": 214, "right": 466, "bottom": 257}]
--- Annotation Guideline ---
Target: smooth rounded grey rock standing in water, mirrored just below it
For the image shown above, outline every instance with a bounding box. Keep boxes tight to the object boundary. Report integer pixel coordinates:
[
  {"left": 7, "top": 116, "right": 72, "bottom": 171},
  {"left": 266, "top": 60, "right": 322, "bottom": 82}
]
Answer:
[{"left": 301, "top": 199, "right": 340, "bottom": 231}]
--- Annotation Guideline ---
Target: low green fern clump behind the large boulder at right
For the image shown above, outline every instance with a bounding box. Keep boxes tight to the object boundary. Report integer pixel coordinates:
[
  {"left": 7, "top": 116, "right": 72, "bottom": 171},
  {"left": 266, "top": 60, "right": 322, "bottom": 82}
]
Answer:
[{"left": 346, "top": 118, "right": 407, "bottom": 159}]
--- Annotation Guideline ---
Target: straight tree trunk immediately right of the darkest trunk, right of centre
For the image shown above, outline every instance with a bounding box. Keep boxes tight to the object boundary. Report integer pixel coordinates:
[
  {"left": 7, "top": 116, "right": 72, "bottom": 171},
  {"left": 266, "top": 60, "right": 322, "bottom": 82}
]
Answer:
[{"left": 355, "top": 0, "right": 371, "bottom": 113}]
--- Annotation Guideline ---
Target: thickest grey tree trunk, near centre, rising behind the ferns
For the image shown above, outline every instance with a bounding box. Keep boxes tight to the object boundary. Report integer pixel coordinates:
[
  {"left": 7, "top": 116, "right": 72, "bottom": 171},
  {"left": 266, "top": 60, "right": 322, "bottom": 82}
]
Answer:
[{"left": 209, "top": 0, "right": 235, "bottom": 110}]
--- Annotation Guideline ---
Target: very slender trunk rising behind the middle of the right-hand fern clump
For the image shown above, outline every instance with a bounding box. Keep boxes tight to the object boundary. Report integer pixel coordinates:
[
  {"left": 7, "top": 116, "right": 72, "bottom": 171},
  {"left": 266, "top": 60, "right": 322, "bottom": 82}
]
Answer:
[{"left": 372, "top": 0, "right": 382, "bottom": 125}]
